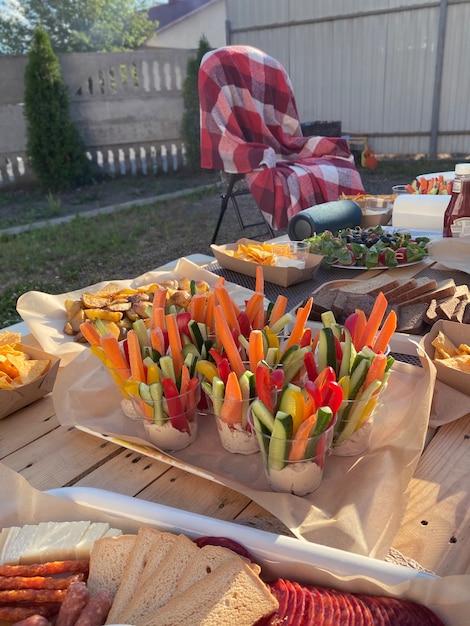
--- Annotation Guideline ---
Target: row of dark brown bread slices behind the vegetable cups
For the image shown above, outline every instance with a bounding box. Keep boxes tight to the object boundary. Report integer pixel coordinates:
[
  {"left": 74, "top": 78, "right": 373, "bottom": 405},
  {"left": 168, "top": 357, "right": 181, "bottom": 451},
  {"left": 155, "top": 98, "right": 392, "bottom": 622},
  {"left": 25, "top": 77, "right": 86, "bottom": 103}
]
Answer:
[{"left": 304, "top": 272, "right": 470, "bottom": 335}]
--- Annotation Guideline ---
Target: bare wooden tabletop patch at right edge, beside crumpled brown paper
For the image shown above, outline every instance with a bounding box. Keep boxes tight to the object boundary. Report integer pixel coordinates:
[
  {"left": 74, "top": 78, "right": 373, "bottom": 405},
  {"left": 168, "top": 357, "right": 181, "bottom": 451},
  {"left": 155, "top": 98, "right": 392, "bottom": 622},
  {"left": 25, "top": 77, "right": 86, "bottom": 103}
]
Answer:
[{"left": 393, "top": 415, "right": 470, "bottom": 576}]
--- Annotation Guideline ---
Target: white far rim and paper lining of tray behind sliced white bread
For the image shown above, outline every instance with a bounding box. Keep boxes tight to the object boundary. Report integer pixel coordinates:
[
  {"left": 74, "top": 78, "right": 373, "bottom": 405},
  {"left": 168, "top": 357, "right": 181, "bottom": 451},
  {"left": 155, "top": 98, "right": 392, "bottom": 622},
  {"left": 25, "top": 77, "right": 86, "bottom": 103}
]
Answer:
[{"left": 42, "top": 487, "right": 469, "bottom": 626}]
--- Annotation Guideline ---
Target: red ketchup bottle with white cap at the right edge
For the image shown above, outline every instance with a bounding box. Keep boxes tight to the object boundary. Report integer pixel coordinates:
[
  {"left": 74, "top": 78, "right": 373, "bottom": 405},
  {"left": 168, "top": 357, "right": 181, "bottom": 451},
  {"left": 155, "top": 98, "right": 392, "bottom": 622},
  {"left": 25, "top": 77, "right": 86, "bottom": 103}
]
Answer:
[{"left": 442, "top": 163, "right": 470, "bottom": 237}]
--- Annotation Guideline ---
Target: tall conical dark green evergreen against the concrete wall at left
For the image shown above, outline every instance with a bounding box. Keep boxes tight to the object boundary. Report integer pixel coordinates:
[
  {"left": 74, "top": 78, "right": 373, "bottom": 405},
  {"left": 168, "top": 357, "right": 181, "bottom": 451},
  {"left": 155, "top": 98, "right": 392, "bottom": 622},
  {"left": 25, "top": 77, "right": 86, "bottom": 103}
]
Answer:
[{"left": 24, "top": 26, "right": 92, "bottom": 191}]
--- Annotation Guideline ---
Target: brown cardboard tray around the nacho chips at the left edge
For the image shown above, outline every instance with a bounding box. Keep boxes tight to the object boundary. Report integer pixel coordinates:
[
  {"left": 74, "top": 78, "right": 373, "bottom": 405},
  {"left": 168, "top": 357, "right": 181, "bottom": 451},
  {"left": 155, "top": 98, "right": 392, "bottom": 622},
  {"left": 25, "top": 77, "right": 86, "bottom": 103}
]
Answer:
[{"left": 0, "top": 344, "right": 60, "bottom": 419}]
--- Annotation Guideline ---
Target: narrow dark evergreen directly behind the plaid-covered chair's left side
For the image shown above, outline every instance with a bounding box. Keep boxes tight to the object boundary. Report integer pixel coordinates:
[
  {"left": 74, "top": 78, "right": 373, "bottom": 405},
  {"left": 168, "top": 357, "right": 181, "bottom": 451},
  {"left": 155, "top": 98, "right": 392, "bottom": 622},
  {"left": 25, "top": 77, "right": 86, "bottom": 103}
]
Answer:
[{"left": 181, "top": 35, "right": 212, "bottom": 169}]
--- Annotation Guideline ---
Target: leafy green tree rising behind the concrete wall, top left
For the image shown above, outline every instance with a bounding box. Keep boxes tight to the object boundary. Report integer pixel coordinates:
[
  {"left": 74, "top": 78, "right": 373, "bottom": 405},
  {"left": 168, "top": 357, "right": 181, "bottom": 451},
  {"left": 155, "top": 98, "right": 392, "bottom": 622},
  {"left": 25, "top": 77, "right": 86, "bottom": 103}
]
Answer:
[{"left": 0, "top": 0, "right": 157, "bottom": 54}]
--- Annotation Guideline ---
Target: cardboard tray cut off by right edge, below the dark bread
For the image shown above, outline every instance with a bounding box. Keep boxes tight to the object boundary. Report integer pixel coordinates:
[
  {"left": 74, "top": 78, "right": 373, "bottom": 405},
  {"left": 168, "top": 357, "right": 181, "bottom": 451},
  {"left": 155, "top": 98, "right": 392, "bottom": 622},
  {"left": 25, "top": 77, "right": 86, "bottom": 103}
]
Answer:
[{"left": 420, "top": 320, "right": 470, "bottom": 395}]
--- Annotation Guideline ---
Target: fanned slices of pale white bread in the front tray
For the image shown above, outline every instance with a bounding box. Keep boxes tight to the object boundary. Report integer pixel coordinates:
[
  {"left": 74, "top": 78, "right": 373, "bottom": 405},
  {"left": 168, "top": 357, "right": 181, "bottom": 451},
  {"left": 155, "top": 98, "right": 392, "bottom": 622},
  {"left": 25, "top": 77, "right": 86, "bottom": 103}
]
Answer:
[{"left": 88, "top": 526, "right": 278, "bottom": 626}]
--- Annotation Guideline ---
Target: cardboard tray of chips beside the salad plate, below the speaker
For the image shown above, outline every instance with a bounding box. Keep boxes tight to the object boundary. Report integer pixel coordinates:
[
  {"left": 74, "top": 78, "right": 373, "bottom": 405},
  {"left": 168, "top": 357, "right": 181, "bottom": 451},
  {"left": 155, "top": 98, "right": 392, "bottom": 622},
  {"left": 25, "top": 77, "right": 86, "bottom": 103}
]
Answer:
[{"left": 211, "top": 239, "right": 323, "bottom": 287}]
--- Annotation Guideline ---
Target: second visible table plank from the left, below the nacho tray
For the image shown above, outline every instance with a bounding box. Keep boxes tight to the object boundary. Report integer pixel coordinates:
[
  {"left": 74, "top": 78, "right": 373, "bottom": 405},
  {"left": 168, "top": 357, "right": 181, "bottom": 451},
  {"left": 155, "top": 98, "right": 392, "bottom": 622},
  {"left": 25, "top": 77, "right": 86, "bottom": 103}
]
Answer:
[{"left": 2, "top": 426, "right": 122, "bottom": 489}]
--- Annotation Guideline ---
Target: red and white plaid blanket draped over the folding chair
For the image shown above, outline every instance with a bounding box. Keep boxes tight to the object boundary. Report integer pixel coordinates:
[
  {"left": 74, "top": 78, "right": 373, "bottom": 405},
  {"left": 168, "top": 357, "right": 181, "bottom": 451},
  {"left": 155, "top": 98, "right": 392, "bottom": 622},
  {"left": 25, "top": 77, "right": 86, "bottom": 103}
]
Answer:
[{"left": 199, "top": 46, "right": 364, "bottom": 230}]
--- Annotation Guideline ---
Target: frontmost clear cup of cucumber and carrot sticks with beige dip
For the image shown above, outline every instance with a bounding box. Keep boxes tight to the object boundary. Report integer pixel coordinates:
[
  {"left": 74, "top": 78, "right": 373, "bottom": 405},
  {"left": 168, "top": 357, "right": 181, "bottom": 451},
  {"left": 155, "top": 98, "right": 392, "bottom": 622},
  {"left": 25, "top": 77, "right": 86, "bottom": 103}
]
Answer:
[{"left": 248, "top": 400, "right": 335, "bottom": 496}]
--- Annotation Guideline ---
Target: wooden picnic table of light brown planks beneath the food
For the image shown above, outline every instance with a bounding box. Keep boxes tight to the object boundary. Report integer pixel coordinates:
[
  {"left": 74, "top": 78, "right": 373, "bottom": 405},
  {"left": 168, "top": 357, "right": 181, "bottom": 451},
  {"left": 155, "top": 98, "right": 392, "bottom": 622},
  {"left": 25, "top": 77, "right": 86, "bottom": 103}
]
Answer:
[{"left": 0, "top": 255, "right": 470, "bottom": 575}]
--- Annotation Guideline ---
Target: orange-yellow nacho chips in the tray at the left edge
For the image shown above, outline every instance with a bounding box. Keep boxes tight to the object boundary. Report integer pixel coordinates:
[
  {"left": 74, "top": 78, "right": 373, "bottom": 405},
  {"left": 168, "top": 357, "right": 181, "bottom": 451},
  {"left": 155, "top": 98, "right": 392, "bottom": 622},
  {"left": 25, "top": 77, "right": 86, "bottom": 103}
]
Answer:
[{"left": 0, "top": 331, "right": 51, "bottom": 389}]
